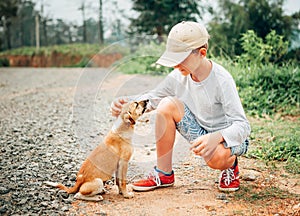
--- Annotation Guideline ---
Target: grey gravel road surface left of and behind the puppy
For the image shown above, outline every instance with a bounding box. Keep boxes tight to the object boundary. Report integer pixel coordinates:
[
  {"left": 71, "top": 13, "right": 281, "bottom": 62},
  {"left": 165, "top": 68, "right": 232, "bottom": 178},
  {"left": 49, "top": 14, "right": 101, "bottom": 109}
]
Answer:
[{"left": 0, "top": 68, "right": 166, "bottom": 215}]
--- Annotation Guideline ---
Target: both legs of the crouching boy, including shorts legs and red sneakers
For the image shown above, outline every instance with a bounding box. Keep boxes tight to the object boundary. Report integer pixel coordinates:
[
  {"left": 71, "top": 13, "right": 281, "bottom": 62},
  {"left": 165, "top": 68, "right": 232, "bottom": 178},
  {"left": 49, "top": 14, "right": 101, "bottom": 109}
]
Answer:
[{"left": 133, "top": 98, "right": 248, "bottom": 191}]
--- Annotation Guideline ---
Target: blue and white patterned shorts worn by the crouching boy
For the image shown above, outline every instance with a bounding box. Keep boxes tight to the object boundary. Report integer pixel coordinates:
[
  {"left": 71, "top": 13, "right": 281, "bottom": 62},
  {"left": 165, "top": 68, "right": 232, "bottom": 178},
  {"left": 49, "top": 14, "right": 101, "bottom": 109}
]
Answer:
[{"left": 176, "top": 104, "right": 249, "bottom": 156}]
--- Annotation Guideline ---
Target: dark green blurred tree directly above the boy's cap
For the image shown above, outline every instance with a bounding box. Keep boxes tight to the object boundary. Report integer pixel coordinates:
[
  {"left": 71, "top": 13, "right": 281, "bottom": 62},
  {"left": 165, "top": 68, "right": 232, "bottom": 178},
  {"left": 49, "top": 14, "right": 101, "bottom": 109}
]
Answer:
[{"left": 130, "top": 0, "right": 201, "bottom": 40}]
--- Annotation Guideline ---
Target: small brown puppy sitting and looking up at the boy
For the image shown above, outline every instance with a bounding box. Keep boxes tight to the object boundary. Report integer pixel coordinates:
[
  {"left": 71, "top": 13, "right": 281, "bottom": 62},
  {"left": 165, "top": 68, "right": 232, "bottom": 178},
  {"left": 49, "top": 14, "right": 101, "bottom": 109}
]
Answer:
[{"left": 45, "top": 100, "right": 148, "bottom": 201}]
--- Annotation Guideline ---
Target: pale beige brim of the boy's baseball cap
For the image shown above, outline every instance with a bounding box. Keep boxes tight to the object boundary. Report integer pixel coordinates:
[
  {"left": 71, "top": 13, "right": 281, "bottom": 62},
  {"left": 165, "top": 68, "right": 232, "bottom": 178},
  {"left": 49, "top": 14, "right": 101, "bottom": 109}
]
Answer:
[{"left": 156, "top": 50, "right": 192, "bottom": 67}]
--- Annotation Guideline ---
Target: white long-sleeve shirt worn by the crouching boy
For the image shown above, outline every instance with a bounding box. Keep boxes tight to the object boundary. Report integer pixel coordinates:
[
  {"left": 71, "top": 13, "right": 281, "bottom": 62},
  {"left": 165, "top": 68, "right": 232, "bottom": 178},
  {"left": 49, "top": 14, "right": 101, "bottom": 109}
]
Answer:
[{"left": 138, "top": 62, "right": 251, "bottom": 147}]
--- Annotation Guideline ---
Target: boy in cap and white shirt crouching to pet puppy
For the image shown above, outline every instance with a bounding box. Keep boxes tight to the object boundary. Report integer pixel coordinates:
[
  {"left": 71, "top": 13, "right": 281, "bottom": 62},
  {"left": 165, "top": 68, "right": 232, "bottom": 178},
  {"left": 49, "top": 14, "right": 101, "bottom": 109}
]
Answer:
[{"left": 111, "top": 21, "right": 251, "bottom": 191}]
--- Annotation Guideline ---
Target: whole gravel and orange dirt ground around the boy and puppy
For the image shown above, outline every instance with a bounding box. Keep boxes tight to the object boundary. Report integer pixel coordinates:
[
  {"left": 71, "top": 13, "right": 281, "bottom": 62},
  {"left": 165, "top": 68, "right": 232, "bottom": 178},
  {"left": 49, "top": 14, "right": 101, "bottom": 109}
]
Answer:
[{"left": 0, "top": 68, "right": 300, "bottom": 215}]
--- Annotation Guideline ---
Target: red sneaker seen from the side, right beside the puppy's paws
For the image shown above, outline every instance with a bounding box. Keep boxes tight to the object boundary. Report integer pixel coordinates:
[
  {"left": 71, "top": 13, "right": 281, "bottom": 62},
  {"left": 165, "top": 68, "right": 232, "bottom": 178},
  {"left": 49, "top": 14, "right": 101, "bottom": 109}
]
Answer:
[{"left": 132, "top": 167, "right": 175, "bottom": 191}]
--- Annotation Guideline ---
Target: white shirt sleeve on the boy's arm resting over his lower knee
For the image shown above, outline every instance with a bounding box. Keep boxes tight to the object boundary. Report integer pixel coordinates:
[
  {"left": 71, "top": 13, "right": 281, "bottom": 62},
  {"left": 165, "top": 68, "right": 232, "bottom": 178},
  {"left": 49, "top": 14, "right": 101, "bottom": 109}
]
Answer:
[{"left": 220, "top": 75, "right": 251, "bottom": 147}]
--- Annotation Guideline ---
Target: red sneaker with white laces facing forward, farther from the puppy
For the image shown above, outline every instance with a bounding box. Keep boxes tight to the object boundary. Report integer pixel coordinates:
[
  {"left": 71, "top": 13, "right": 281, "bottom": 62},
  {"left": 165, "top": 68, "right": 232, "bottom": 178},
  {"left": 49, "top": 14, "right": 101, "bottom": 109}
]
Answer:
[{"left": 219, "top": 160, "right": 240, "bottom": 192}]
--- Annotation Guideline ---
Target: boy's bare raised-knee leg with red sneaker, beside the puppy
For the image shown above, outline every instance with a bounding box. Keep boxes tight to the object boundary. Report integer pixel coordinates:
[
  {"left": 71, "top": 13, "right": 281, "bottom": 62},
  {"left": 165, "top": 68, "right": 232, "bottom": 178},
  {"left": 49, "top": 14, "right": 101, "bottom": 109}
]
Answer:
[{"left": 132, "top": 98, "right": 184, "bottom": 191}]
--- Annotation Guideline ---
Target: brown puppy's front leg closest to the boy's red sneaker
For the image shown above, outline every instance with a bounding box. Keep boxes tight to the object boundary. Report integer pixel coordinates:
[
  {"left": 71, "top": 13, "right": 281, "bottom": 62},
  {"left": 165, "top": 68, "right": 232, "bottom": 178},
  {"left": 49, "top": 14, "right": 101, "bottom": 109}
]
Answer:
[{"left": 116, "top": 159, "right": 134, "bottom": 198}]
